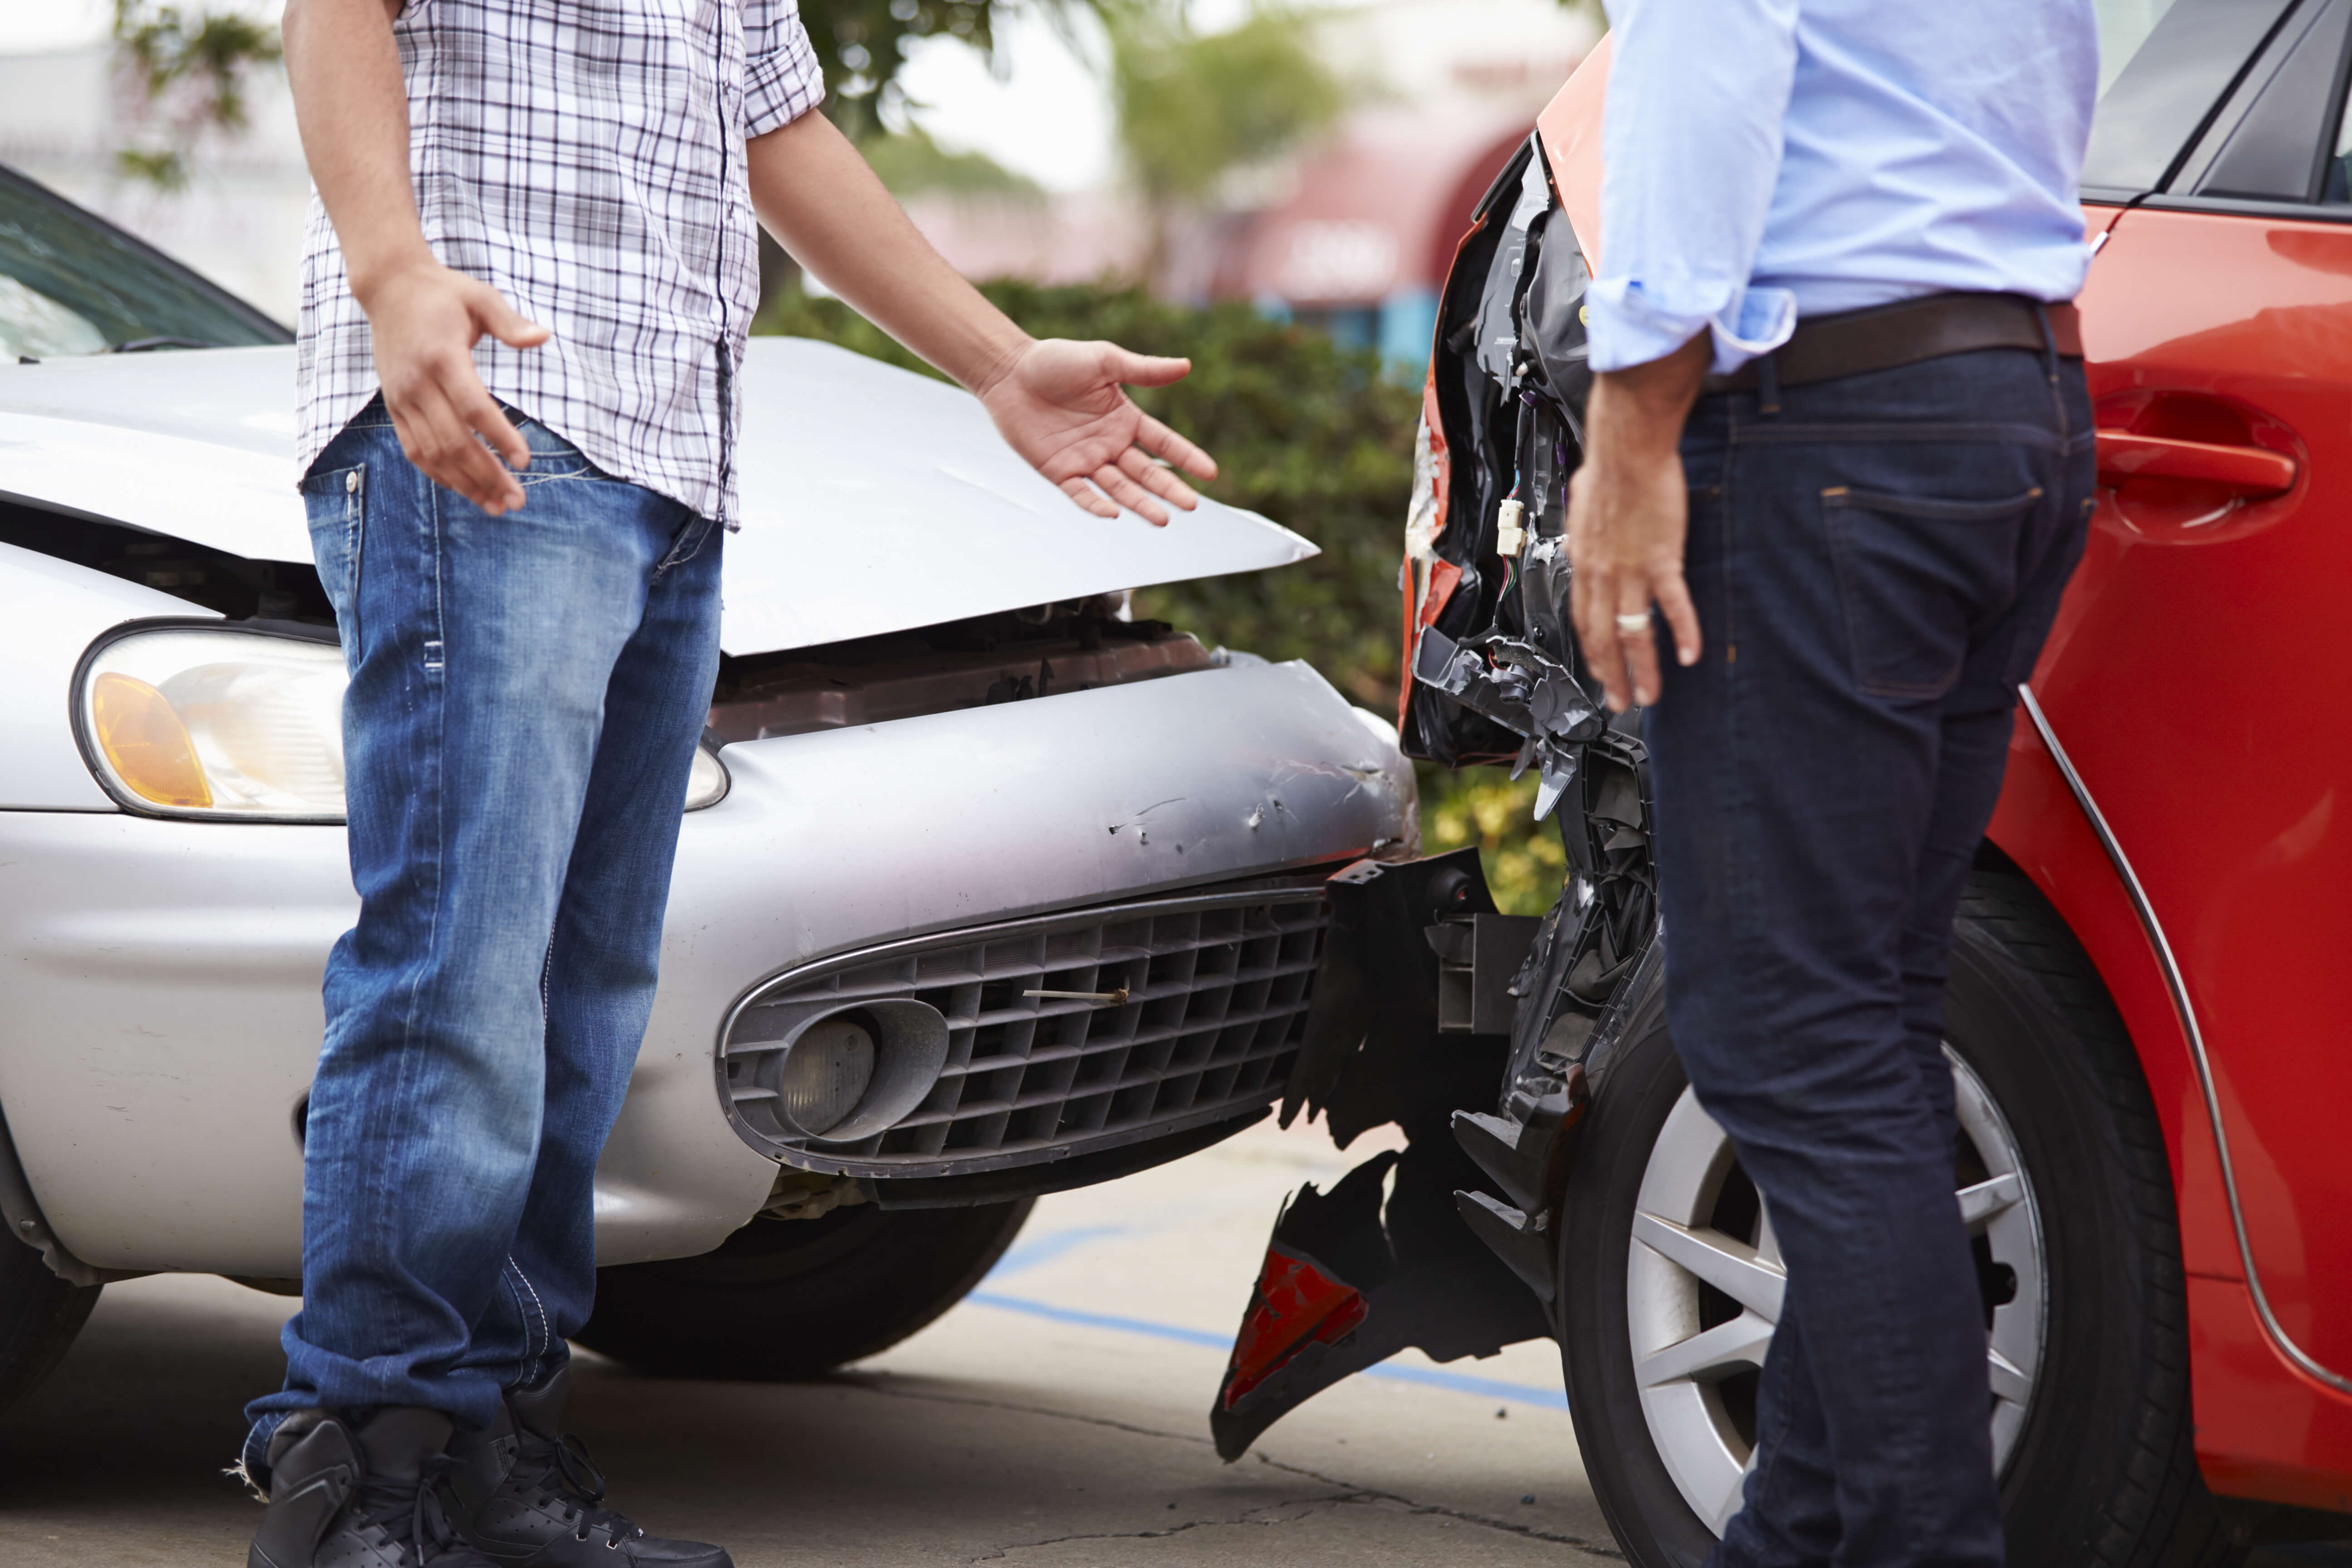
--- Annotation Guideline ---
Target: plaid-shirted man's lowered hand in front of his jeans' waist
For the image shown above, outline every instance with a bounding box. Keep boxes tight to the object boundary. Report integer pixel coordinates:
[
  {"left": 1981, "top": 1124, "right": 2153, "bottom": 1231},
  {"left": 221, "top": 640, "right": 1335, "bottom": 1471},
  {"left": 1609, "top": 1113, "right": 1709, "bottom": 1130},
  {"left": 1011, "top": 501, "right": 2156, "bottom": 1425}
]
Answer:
[{"left": 360, "top": 261, "right": 548, "bottom": 517}]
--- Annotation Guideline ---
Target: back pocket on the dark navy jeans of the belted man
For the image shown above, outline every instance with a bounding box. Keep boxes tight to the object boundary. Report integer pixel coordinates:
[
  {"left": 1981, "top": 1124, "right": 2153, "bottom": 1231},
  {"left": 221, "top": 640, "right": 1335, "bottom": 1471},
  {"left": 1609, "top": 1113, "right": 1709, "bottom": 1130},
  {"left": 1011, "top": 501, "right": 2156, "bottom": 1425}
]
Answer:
[{"left": 1820, "top": 484, "right": 2042, "bottom": 698}]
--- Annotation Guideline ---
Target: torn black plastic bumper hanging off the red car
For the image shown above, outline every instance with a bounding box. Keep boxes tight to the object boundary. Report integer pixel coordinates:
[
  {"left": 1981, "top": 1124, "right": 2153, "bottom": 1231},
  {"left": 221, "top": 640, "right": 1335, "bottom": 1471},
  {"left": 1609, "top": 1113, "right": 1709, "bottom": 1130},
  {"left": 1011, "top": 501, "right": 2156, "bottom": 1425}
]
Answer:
[{"left": 1209, "top": 729, "right": 1663, "bottom": 1460}]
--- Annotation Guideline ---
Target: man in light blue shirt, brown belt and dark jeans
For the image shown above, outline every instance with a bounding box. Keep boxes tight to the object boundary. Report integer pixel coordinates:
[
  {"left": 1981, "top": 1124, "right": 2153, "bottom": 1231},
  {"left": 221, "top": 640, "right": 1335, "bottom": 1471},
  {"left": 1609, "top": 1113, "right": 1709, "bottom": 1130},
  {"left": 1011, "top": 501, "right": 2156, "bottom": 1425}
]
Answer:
[{"left": 1569, "top": 0, "right": 2098, "bottom": 1568}]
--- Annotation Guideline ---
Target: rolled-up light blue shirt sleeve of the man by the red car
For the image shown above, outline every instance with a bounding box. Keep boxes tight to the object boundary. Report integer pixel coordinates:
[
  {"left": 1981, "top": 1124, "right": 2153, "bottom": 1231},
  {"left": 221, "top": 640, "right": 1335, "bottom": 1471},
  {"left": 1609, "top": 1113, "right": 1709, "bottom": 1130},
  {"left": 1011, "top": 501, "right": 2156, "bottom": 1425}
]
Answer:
[{"left": 1590, "top": 0, "right": 1797, "bottom": 374}]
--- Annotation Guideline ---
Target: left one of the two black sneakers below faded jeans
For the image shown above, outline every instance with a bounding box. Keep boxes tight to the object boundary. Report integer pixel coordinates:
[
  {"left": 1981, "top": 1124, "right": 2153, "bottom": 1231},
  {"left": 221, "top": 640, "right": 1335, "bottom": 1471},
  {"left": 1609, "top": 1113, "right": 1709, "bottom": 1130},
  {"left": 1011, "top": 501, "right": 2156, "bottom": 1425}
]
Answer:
[{"left": 245, "top": 1406, "right": 494, "bottom": 1568}]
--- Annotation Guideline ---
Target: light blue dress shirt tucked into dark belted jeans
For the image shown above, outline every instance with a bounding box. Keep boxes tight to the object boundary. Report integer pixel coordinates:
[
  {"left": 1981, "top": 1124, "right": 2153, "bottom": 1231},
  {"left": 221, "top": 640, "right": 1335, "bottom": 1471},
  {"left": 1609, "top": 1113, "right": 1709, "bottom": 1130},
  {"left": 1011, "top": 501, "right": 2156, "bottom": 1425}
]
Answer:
[{"left": 1590, "top": 0, "right": 2098, "bottom": 372}]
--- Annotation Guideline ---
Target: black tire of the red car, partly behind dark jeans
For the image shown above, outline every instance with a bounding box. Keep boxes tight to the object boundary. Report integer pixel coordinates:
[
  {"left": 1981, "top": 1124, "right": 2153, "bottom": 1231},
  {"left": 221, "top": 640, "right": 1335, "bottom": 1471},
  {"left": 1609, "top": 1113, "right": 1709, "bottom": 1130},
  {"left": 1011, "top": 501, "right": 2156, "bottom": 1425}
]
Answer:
[{"left": 1559, "top": 872, "right": 2246, "bottom": 1568}]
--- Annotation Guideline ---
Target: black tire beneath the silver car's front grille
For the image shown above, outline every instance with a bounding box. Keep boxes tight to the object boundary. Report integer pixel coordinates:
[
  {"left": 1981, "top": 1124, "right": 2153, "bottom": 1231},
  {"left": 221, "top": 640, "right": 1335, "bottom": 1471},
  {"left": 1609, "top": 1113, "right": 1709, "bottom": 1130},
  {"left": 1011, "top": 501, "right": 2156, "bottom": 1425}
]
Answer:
[{"left": 576, "top": 1199, "right": 1033, "bottom": 1382}]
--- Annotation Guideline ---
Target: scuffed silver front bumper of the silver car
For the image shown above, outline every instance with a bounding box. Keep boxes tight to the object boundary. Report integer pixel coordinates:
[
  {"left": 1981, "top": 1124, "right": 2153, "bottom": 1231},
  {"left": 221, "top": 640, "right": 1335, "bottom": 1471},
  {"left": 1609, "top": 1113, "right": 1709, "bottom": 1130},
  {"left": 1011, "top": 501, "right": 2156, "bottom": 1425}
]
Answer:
[{"left": 0, "top": 663, "right": 1414, "bottom": 1277}]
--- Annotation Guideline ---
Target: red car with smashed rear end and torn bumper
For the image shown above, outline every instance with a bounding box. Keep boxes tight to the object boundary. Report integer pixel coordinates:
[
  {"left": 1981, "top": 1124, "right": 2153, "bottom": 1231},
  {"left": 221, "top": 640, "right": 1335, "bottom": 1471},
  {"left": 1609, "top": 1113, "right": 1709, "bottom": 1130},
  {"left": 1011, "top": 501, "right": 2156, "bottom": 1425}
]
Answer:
[{"left": 1214, "top": 0, "right": 2352, "bottom": 1568}]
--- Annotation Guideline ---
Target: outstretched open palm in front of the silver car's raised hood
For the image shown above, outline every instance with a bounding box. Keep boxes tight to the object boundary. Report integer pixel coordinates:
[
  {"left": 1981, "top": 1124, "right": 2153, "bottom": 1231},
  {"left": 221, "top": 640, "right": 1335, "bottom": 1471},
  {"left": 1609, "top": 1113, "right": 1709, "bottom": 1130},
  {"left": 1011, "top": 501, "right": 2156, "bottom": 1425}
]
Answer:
[{"left": 979, "top": 338, "right": 1216, "bottom": 527}]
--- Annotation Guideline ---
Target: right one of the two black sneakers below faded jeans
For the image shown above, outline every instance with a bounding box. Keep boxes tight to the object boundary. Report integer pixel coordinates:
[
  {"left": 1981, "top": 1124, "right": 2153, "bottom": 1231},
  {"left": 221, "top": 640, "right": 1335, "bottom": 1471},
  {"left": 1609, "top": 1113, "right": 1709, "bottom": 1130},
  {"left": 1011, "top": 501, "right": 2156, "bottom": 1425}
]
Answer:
[{"left": 435, "top": 1366, "right": 734, "bottom": 1568}]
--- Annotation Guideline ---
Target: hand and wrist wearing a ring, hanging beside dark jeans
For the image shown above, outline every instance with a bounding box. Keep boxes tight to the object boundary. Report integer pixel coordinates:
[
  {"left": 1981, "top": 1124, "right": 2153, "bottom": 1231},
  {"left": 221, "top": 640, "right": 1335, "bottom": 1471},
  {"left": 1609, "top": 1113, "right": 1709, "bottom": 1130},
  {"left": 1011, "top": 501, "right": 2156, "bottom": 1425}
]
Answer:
[{"left": 1569, "top": 334, "right": 1708, "bottom": 712}]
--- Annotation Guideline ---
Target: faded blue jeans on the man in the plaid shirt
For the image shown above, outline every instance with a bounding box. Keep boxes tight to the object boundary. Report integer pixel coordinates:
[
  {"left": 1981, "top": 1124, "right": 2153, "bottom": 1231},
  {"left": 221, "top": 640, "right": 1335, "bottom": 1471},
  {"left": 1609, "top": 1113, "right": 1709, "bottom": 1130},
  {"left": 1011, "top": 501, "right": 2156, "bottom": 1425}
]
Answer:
[{"left": 245, "top": 400, "right": 722, "bottom": 1479}]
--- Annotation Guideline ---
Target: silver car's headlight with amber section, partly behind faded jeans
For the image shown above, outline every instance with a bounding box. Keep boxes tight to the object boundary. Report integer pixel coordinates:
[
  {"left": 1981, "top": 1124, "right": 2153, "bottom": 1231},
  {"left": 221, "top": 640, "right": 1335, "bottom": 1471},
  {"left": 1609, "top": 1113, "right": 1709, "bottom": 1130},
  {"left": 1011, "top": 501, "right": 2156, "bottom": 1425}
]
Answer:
[{"left": 73, "top": 625, "right": 727, "bottom": 823}]
